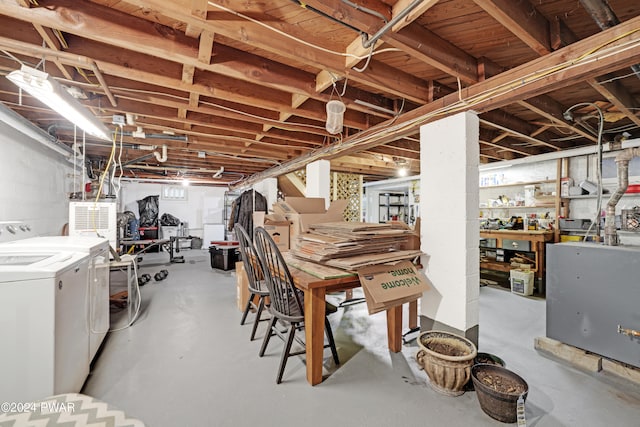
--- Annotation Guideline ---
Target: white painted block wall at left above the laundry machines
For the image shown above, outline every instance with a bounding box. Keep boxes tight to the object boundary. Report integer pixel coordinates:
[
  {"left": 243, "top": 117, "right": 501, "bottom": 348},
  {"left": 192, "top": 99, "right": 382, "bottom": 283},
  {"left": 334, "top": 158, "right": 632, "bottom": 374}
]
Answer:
[{"left": 0, "top": 122, "right": 79, "bottom": 235}]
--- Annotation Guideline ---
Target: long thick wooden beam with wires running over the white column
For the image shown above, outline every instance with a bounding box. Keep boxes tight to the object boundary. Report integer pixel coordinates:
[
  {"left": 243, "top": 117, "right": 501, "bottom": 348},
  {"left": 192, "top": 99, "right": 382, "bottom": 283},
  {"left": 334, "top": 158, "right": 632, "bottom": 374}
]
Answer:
[{"left": 238, "top": 17, "right": 640, "bottom": 186}]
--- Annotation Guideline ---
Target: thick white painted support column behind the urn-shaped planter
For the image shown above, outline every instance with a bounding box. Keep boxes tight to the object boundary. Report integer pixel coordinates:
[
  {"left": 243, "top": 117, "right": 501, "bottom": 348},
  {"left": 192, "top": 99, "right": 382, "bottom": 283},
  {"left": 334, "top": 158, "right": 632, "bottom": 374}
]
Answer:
[{"left": 420, "top": 112, "right": 480, "bottom": 344}]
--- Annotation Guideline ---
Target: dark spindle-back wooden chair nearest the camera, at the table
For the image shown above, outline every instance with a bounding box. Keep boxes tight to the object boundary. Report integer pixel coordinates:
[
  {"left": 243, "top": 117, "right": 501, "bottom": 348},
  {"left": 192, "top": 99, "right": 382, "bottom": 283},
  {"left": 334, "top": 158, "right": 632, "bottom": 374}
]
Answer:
[{"left": 254, "top": 227, "right": 340, "bottom": 384}]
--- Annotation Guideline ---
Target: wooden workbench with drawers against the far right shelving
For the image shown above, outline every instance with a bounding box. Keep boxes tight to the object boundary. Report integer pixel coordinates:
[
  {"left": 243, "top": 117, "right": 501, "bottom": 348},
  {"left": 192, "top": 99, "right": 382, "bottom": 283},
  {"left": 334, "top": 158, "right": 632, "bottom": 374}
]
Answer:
[{"left": 480, "top": 230, "right": 554, "bottom": 279}]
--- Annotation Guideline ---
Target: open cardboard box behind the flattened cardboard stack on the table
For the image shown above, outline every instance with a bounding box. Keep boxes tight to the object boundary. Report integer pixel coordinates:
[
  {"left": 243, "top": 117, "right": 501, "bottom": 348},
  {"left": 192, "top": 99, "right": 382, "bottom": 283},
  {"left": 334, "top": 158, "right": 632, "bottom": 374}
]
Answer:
[{"left": 273, "top": 197, "right": 349, "bottom": 239}]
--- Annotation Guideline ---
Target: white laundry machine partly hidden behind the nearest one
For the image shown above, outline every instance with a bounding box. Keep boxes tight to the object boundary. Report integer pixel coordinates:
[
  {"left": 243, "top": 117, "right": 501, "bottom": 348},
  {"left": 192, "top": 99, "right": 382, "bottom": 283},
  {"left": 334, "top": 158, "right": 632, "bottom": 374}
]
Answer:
[{"left": 0, "top": 236, "right": 109, "bottom": 363}]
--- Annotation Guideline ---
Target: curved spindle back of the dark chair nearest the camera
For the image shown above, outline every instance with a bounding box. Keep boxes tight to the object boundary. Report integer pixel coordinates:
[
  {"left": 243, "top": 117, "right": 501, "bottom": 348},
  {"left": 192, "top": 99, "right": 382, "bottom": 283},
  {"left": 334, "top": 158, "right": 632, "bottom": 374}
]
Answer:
[{"left": 253, "top": 227, "right": 304, "bottom": 321}]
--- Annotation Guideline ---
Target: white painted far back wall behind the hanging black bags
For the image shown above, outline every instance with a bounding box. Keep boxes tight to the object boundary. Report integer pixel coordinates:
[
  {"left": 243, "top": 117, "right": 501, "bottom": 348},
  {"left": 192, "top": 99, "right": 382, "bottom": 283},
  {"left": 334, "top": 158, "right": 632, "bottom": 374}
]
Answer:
[{"left": 119, "top": 182, "right": 226, "bottom": 237}]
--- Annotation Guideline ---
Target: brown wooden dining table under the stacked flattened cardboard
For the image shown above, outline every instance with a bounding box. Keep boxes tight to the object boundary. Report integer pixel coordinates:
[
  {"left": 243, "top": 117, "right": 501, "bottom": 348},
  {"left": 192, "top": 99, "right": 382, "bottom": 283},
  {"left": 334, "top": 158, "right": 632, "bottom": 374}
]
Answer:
[{"left": 285, "top": 257, "right": 418, "bottom": 385}]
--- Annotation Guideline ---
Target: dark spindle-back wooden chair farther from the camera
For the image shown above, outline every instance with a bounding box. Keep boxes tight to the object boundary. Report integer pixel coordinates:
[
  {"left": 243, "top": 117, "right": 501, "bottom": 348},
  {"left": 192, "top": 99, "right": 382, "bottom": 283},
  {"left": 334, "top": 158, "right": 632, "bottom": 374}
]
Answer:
[{"left": 235, "top": 224, "right": 270, "bottom": 341}]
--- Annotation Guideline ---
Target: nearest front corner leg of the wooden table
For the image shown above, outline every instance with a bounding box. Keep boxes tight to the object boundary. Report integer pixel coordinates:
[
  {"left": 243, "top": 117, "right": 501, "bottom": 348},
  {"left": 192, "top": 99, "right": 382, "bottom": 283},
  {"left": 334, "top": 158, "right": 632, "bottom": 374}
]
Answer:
[{"left": 304, "top": 288, "right": 326, "bottom": 385}]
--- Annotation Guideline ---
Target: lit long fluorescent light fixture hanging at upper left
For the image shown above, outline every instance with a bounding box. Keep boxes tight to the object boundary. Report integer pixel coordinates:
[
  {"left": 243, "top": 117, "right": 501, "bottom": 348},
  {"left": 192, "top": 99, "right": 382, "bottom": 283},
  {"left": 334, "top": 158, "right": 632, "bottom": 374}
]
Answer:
[{"left": 7, "top": 65, "right": 111, "bottom": 141}]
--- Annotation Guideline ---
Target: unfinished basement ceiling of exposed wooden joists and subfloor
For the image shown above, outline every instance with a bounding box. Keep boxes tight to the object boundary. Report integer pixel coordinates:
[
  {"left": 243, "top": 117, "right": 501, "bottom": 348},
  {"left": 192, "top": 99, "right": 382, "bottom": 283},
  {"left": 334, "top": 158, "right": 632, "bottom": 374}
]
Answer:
[{"left": 0, "top": 0, "right": 640, "bottom": 186}]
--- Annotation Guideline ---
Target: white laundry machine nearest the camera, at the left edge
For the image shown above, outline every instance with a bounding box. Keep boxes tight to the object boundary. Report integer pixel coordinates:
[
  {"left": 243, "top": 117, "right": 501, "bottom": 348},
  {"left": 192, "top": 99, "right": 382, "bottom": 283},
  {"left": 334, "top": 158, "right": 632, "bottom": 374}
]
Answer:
[{"left": 0, "top": 249, "right": 89, "bottom": 402}]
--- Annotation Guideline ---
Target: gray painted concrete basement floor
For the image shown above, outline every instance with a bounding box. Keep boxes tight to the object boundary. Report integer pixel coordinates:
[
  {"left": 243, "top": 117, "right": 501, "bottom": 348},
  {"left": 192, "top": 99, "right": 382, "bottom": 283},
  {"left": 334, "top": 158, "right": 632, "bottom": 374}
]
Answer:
[{"left": 82, "top": 250, "right": 640, "bottom": 427}]
